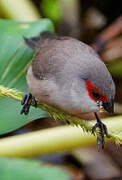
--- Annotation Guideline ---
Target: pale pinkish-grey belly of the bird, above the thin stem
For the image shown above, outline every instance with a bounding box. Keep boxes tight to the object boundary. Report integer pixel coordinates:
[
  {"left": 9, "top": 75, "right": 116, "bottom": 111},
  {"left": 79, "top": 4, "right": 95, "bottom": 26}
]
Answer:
[{"left": 27, "top": 66, "right": 97, "bottom": 115}]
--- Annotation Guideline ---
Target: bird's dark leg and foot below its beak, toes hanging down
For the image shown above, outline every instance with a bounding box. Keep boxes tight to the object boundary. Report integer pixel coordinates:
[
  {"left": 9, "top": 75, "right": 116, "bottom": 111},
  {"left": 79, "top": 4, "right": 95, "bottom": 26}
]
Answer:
[{"left": 92, "top": 112, "right": 110, "bottom": 151}]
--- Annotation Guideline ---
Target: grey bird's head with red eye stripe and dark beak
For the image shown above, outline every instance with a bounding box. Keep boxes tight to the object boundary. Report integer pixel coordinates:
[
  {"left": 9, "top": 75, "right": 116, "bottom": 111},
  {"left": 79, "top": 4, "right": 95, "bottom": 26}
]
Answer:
[{"left": 69, "top": 56, "right": 115, "bottom": 114}]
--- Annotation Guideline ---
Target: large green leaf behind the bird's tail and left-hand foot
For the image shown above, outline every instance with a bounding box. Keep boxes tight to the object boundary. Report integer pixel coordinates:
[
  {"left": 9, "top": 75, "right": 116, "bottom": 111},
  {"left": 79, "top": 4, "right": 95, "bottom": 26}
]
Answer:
[{"left": 0, "top": 20, "right": 53, "bottom": 134}]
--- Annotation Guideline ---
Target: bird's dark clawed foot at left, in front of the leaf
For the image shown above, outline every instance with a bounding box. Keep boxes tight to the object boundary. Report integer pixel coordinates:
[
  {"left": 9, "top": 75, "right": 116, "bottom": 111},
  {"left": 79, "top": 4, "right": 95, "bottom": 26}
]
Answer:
[{"left": 20, "top": 93, "right": 37, "bottom": 115}]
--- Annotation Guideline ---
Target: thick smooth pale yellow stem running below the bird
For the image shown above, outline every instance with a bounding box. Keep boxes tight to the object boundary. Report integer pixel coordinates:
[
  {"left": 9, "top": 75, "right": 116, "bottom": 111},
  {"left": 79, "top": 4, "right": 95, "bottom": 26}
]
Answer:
[{"left": 0, "top": 116, "right": 122, "bottom": 158}]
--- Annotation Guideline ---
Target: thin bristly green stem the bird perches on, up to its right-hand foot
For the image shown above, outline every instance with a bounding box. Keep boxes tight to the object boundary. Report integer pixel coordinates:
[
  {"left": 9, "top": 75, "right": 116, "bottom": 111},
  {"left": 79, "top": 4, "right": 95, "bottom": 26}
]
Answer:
[{"left": 0, "top": 85, "right": 92, "bottom": 132}]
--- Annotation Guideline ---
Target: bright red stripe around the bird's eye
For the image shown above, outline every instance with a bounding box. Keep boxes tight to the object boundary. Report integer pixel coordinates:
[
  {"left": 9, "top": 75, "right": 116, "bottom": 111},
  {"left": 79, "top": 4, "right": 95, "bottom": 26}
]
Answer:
[{"left": 86, "top": 80, "right": 108, "bottom": 102}]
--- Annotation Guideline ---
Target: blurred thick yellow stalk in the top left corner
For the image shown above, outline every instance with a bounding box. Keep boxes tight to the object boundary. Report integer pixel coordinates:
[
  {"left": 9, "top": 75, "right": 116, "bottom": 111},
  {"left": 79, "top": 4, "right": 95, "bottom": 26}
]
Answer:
[{"left": 0, "top": 0, "right": 40, "bottom": 21}]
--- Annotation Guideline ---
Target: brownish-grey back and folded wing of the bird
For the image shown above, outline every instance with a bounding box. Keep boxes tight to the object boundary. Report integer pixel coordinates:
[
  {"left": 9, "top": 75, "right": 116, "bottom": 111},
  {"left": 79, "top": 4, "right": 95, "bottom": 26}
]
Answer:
[{"left": 32, "top": 33, "right": 97, "bottom": 79}]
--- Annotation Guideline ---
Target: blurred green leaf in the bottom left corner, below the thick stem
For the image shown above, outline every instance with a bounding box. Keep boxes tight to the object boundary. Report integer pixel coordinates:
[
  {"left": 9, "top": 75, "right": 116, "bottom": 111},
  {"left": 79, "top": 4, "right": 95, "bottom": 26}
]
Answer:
[{"left": 0, "top": 158, "right": 69, "bottom": 180}]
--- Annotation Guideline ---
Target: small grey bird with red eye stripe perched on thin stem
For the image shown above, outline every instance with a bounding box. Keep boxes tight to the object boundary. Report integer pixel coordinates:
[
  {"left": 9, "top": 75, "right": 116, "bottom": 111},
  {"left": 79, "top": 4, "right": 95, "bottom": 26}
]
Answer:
[{"left": 21, "top": 32, "right": 116, "bottom": 150}]
